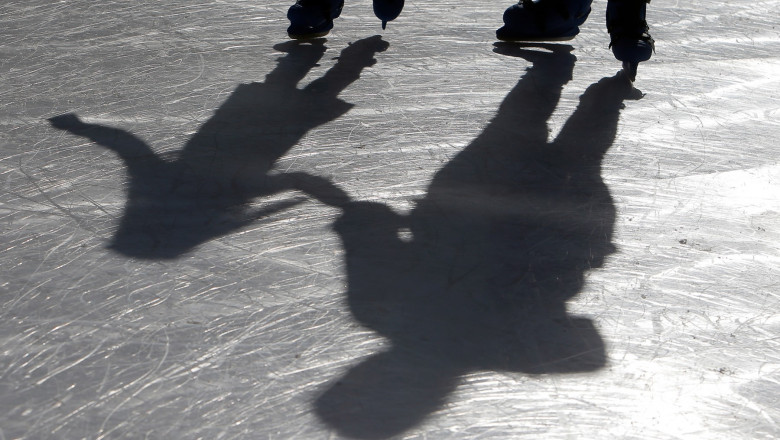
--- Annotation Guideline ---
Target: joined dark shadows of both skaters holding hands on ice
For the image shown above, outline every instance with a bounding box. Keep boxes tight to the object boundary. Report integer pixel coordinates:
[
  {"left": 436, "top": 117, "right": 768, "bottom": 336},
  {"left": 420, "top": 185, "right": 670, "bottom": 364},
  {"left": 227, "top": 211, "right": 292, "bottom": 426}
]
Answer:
[{"left": 51, "top": 37, "right": 636, "bottom": 439}]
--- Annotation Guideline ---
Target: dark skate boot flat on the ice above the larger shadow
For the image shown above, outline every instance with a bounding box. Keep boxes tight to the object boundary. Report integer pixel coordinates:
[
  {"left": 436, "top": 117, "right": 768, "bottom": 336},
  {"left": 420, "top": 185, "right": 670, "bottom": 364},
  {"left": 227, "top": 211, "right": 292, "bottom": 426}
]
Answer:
[{"left": 496, "top": 0, "right": 592, "bottom": 41}]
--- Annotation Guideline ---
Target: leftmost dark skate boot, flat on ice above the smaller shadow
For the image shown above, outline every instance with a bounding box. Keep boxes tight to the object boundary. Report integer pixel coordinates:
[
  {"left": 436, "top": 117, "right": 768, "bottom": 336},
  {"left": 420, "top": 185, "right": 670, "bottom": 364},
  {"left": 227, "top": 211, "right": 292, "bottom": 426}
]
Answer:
[{"left": 287, "top": 0, "right": 344, "bottom": 40}]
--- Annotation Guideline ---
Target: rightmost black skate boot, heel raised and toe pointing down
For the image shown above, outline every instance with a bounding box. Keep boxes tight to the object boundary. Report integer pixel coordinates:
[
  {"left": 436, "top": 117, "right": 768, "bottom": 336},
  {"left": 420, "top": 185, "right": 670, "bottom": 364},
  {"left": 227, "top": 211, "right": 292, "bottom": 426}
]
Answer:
[{"left": 607, "top": 0, "right": 655, "bottom": 82}]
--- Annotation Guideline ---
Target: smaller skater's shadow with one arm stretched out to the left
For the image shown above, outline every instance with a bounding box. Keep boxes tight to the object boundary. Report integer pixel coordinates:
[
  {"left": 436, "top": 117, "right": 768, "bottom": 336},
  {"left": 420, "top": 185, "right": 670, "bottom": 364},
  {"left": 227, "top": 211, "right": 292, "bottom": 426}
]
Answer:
[{"left": 49, "top": 36, "right": 388, "bottom": 259}]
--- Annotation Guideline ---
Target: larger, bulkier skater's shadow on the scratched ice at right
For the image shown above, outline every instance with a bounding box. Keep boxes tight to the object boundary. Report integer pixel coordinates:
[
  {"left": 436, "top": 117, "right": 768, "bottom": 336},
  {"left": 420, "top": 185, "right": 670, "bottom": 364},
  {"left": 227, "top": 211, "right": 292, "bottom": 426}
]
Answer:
[{"left": 312, "top": 45, "right": 631, "bottom": 439}]
